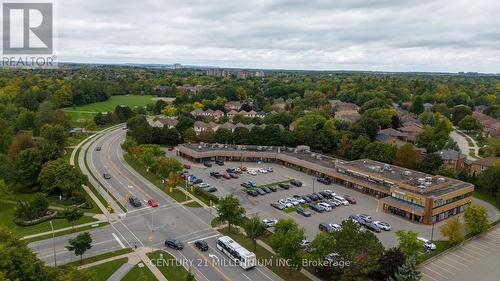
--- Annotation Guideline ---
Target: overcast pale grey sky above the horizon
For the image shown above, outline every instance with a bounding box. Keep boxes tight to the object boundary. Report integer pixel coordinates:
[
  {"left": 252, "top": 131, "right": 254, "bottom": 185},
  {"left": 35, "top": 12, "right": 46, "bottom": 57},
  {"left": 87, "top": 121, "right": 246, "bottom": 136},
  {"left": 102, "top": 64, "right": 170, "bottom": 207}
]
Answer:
[{"left": 57, "top": 0, "right": 500, "bottom": 73}]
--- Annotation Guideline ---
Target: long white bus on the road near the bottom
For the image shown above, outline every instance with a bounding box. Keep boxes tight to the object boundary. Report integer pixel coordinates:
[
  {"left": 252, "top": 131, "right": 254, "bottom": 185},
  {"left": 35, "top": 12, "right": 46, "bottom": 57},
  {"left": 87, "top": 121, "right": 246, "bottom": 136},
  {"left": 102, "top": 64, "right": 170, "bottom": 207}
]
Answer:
[{"left": 217, "top": 236, "right": 257, "bottom": 269}]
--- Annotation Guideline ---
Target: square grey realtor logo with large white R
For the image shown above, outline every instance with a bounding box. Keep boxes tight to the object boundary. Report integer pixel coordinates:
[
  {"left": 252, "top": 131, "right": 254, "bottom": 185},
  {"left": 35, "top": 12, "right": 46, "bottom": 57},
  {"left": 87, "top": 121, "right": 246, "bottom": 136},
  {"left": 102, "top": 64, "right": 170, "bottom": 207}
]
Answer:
[{"left": 2, "top": 3, "right": 53, "bottom": 55}]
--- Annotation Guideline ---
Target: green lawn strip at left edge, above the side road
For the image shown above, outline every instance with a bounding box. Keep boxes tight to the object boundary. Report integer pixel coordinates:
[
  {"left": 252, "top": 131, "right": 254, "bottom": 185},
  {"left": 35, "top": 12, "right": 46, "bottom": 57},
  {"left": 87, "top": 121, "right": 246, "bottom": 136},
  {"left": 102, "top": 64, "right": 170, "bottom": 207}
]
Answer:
[{"left": 0, "top": 202, "right": 97, "bottom": 237}]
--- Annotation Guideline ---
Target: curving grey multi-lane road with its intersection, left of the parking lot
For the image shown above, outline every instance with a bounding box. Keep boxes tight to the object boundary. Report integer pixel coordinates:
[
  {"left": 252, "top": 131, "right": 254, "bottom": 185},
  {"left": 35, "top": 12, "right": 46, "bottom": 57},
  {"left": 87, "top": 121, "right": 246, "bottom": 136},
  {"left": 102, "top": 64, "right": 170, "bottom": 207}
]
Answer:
[{"left": 29, "top": 128, "right": 281, "bottom": 281}]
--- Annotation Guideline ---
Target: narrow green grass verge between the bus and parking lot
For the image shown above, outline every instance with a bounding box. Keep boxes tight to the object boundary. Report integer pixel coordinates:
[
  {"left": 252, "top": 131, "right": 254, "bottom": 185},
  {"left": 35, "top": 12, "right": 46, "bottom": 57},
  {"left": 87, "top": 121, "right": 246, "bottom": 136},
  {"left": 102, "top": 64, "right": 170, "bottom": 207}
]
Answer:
[{"left": 220, "top": 228, "right": 310, "bottom": 281}]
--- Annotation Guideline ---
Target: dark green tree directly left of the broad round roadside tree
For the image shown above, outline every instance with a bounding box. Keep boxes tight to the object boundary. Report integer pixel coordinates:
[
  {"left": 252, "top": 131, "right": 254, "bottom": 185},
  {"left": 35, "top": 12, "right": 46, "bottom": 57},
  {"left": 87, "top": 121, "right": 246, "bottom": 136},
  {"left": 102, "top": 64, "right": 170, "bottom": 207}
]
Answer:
[{"left": 15, "top": 148, "right": 43, "bottom": 186}]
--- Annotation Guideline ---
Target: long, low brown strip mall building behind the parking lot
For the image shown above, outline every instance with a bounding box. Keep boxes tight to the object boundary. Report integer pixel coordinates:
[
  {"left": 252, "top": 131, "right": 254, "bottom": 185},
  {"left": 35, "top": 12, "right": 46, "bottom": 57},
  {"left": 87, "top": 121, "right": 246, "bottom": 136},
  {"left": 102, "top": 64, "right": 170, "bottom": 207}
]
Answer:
[{"left": 177, "top": 143, "right": 474, "bottom": 224}]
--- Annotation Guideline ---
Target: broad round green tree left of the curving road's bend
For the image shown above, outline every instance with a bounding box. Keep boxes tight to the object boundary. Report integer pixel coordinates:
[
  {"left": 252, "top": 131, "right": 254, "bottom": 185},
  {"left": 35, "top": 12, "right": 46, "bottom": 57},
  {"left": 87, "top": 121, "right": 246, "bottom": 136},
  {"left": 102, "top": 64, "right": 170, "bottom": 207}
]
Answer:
[{"left": 38, "top": 158, "right": 87, "bottom": 198}]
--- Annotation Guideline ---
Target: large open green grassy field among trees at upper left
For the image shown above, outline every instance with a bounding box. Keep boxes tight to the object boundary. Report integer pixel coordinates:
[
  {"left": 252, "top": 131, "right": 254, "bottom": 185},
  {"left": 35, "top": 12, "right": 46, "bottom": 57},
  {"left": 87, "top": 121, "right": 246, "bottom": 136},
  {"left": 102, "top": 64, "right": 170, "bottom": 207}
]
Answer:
[{"left": 63, "top": 95, "right": 153, "bottom": 122}]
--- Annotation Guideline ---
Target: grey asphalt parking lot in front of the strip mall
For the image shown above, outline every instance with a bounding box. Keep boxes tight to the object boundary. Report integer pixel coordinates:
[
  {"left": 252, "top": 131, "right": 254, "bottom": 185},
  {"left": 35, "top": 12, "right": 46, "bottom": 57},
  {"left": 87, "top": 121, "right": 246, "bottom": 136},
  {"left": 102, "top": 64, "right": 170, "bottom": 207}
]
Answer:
[{"left": 169, "top": 151, "right": 443, "bottom": 247}]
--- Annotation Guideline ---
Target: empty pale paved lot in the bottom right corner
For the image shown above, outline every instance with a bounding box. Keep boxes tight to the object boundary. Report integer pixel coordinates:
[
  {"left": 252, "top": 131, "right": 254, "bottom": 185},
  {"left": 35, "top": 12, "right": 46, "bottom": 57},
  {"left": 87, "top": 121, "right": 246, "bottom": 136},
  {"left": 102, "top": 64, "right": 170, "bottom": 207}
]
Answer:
[{"left": 420, "top": 225, "right": 500, "bottom": 281}]
